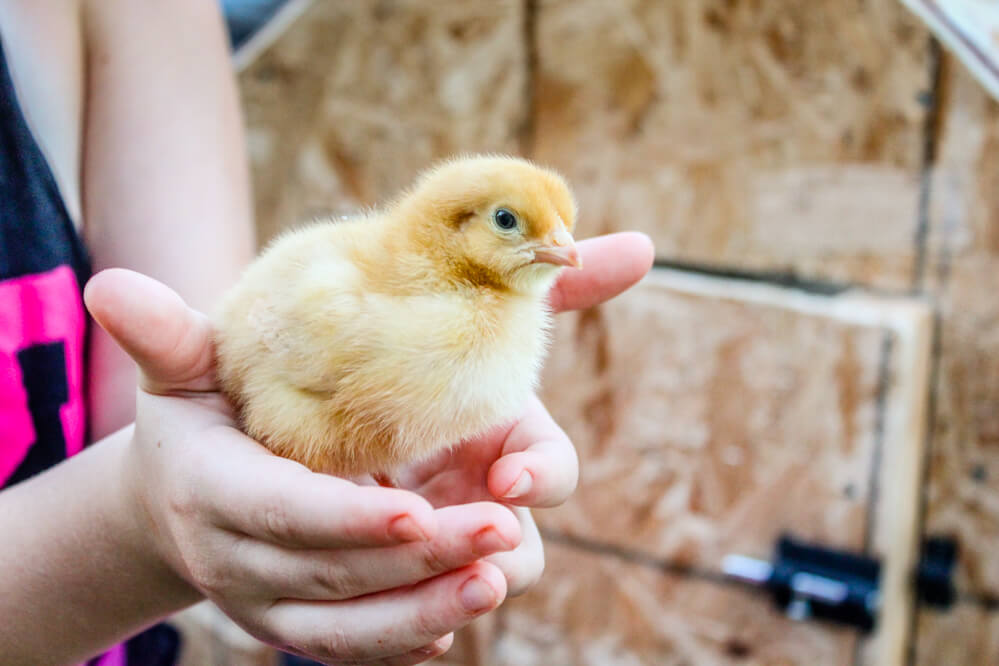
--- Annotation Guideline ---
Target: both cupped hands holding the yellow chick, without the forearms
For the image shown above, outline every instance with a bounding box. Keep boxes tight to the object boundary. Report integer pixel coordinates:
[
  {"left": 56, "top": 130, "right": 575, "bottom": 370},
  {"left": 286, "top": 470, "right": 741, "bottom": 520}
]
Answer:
[{"left": 85, "top": 234, "right": 651, "bottom": 665}]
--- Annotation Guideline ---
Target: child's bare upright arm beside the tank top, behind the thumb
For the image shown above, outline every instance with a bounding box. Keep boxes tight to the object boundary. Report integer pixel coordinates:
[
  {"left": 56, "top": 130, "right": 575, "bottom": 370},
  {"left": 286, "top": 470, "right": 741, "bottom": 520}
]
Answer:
[{"left": 81, "top": 0, "right": 254, "bottom": 439}]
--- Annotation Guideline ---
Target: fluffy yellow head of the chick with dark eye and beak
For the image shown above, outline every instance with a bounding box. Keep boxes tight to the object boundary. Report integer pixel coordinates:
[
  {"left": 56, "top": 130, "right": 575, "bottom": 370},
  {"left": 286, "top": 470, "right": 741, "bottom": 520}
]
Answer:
[{"left": 400, "top": 156, "right": 582, "bottom": 293}]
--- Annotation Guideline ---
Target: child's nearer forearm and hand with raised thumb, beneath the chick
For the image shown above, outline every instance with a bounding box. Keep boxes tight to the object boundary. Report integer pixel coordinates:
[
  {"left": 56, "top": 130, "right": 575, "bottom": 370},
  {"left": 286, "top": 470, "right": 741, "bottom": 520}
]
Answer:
[{"left": 0, "top": 271, "right": 512, "bottom": 666}]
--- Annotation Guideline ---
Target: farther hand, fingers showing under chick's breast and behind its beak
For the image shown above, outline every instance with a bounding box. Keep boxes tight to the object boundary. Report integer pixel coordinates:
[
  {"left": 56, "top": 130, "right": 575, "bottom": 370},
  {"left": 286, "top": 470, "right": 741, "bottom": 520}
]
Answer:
[{"left": 397, "top": 232, "right": 653, "bottom": 596}]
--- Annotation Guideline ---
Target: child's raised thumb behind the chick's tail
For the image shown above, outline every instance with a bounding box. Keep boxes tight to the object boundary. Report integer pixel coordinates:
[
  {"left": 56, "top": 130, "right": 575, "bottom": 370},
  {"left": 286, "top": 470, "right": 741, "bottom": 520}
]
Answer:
[{"left": 83, "top": 268, "right": 216, "bottom": 393}]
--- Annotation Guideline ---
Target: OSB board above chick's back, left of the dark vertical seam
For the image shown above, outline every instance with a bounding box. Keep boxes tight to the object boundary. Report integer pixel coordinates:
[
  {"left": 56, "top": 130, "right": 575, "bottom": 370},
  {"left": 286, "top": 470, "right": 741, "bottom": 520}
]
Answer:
[{"left": 240, "top": 0, "right": 528, "bottom": 240}]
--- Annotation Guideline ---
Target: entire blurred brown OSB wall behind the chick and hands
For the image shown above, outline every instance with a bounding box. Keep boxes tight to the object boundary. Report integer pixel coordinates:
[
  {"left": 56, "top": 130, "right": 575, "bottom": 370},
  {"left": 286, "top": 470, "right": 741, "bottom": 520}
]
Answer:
[{"left": 229, "top": 0, "right": 999, "bottom": 666}]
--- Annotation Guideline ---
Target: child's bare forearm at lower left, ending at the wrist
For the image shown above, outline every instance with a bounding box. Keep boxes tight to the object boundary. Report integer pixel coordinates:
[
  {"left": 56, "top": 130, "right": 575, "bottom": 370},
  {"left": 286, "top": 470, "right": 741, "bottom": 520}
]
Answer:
[{"left": 0, "top": 428, "right": 200, "bottom": 666}]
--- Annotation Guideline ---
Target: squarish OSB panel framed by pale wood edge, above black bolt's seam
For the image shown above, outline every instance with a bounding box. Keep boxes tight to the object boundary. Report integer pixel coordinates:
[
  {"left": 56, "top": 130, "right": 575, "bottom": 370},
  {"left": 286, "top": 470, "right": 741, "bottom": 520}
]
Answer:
[{"left": 542, "top": 279, "right": 885, "bottom": 566}]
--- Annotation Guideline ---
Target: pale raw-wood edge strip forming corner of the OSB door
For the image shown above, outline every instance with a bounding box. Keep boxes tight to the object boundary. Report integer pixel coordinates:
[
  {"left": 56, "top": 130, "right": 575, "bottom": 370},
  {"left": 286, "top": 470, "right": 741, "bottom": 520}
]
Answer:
[{"left": 645, "top": 268, "right": 933, "bottom": 666}]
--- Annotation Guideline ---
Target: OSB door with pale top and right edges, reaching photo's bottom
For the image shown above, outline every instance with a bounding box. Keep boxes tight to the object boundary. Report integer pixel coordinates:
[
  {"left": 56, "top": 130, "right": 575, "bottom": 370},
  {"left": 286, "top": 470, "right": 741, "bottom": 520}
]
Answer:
[{"left": 492, "top": 270, "right": 929, "bottom": 666}]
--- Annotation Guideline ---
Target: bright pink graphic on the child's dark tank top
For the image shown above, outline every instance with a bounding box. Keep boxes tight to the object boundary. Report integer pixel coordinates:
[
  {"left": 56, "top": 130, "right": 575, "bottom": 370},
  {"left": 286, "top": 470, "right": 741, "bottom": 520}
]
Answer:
[{"left": 0, "top": 266, "right": 85, "bottom": 486}]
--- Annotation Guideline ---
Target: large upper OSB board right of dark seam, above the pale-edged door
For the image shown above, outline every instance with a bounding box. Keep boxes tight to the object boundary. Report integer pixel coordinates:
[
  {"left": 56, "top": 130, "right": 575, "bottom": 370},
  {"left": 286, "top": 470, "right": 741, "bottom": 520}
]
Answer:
[{"left": 532, "top": 0, "right": 929, "bottom": 288}]
